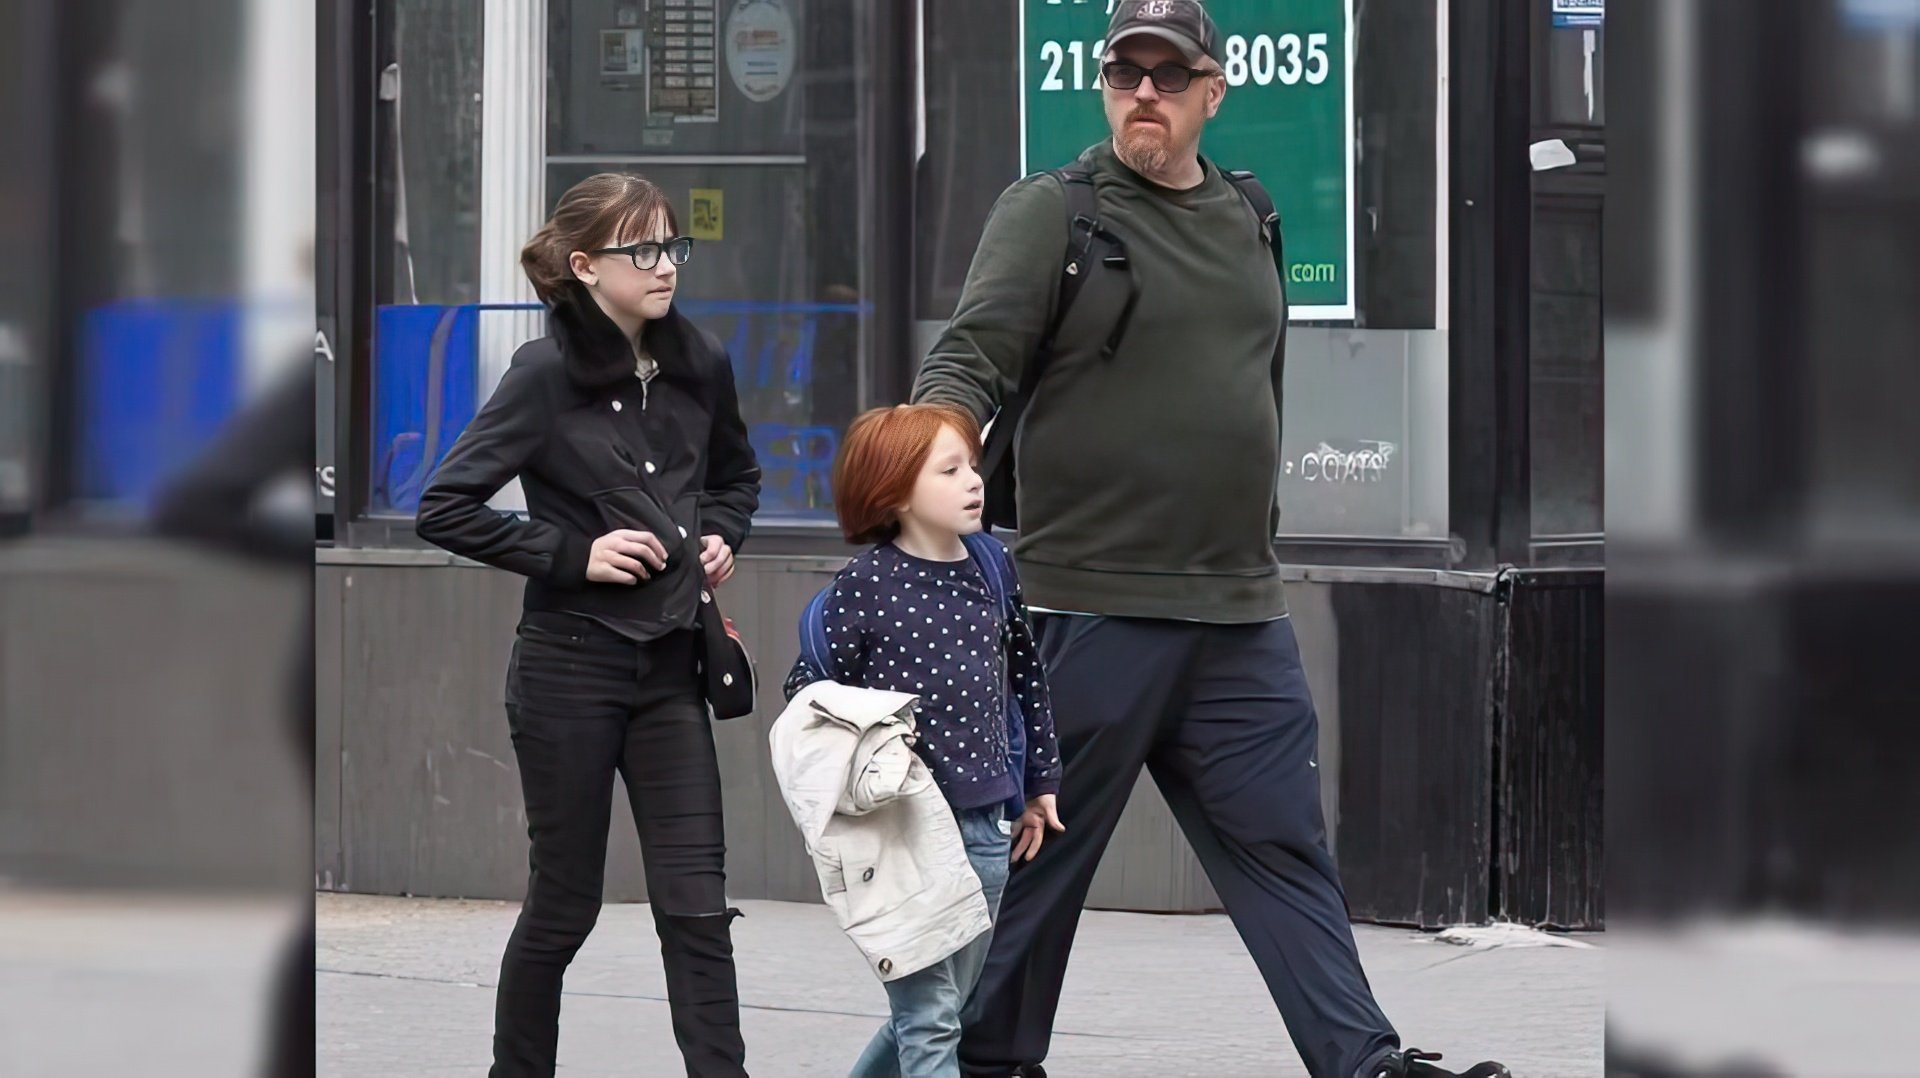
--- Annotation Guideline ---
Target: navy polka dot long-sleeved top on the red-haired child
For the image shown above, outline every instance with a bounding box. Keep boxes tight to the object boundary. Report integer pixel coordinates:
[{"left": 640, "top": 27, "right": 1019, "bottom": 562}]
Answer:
[{"left": 785, "top": 544, "right": 1060, "bottom": 809}]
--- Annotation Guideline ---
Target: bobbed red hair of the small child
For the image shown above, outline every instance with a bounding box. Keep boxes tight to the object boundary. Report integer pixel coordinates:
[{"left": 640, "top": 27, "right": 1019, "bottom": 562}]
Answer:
[{"left": 833, "top": 404, "right": 979, "bottom": 542}]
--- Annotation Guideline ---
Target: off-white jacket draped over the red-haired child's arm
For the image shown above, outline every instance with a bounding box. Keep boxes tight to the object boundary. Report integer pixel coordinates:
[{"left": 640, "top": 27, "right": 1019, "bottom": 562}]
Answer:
[{"left": 768, "top": 680, "right": 993, "bottom": 980}]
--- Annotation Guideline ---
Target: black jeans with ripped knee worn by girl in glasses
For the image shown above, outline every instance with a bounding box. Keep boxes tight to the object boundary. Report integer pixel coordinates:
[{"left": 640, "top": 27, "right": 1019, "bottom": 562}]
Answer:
[{"left": 492, "top": 613, "right": 747, "bottom": 1078}]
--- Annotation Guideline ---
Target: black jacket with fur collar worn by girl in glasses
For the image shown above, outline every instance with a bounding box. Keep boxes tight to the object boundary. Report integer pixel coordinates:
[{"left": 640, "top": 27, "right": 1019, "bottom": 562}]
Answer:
[{"left": 415, "top": 284, "right": 760, "bottom": 640}]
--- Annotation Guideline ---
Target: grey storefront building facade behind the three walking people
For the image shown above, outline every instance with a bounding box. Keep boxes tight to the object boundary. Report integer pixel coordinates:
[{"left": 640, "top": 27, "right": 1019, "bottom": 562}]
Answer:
[{"left": 315, "top": 0, "right": 1605, "bottom": 926}]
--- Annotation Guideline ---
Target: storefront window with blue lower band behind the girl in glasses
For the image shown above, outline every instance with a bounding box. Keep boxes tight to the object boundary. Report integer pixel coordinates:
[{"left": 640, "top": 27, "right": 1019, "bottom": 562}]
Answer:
[{"left": 360, "top": 0, "right": 872, "bottom": 523}]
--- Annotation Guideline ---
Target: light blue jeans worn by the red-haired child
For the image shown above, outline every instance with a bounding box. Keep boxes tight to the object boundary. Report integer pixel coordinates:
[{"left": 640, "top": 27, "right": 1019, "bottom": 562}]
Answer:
[{"left": 852, "top": 805, "right": 1014, "bottom": 1078}]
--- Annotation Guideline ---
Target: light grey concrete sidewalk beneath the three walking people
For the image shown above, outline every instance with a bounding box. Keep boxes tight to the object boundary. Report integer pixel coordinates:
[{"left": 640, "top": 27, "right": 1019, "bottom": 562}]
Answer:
[{"left": 317, "top": 894, "right": 1605, "bottom": 1078}]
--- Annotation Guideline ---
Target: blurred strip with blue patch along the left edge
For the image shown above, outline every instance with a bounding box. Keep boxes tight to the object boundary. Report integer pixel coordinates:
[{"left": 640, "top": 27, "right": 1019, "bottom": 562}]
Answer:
[{"left": 0, "top": 0, "right": 315, "bottom": 1076}]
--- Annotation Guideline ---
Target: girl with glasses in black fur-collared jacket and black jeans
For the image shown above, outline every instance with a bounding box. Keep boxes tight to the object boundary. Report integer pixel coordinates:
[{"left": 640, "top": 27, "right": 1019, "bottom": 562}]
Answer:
[{"left": 419, "top": 173, "right": 760, "bottom": 1078}]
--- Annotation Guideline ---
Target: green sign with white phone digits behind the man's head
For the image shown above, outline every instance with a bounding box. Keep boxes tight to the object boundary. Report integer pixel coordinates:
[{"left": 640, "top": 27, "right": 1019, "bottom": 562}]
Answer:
[{"left": 1020, "top": 0, "right": 1354, "bottom": 319}]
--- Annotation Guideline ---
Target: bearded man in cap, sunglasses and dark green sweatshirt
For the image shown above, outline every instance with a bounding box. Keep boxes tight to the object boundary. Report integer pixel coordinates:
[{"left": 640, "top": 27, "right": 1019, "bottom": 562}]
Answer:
[{"left": 914, "top": 0, "right": 1507, "bottom": 1078}]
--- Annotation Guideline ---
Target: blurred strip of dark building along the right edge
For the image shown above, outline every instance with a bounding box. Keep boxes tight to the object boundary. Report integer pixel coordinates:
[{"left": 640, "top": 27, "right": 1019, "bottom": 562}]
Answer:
[{"left": 1605, "top": 0, "right": 1920, "bottom": 1074}]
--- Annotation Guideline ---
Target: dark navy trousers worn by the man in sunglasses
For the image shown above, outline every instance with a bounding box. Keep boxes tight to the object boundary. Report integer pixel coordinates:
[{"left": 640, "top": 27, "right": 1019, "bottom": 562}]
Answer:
[{"left": 960, "top": 615, "right": 1400, "bottom": 1078}]
